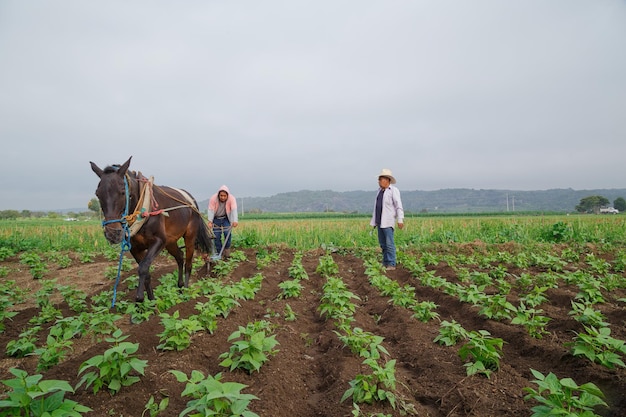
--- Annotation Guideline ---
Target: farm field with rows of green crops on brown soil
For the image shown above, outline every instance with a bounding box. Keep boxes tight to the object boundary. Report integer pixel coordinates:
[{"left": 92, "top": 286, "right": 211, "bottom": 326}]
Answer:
[{"left": 0, "top": 215, "right": 626, "bottom": 417}]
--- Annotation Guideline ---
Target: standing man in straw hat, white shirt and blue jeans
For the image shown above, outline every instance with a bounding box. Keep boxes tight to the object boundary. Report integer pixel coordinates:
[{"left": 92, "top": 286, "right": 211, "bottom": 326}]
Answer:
[{"left": 370, "top": 168, "right": 404, "bottom": 270}]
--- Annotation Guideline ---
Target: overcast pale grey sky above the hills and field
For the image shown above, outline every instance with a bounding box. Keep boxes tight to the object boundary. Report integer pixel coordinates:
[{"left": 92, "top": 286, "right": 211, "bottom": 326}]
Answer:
[{"left": 0, "top": 0, "right": 626, "bottom": 211}]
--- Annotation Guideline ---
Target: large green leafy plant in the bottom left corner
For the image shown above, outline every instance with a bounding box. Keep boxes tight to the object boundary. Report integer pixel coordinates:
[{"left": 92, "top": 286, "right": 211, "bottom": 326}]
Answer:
[{"left": 0, "top": 368, "right": 92, "bottom": 417}]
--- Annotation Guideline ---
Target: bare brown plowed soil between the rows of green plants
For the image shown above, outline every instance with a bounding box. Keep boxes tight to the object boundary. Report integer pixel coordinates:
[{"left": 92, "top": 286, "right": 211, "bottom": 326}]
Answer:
[{"left": 0, "top": 246, "right": 626, "bottom": 417}]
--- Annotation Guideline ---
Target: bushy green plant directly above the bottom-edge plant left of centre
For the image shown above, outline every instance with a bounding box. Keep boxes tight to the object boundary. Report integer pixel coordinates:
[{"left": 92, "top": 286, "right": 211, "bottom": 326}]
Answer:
[{"left": 220, "top": 320, "right": 278, "bottom": 374}]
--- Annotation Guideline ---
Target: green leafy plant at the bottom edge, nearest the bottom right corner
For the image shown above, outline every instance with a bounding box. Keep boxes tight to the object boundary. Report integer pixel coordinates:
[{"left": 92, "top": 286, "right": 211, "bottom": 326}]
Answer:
[{"left": 524, "top": 369, "right": 607, "bottom": 417}]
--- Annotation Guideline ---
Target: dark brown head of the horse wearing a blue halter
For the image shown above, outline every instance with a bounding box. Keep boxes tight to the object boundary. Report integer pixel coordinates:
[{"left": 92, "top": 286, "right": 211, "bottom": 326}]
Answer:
[{"left": 90, "top": 156, "right": 132, "bottom": 244}]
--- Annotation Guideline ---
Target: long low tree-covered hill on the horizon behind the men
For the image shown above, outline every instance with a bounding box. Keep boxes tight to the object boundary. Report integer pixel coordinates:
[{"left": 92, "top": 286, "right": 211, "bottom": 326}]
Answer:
[{"left": 199, "top": 188, "right": 626, "bottom": 213}]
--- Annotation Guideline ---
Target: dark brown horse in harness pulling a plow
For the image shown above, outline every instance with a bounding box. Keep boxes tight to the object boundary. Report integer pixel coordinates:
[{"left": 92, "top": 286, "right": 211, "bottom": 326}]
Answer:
[{"left": 90, "top": 156, "right": 214, "bottom": 302}]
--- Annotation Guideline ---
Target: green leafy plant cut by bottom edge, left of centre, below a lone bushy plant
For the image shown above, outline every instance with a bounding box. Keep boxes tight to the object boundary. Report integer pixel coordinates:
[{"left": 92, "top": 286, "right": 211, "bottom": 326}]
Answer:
[{"left": 170, "top": 370, "right": 259, "bottom": 417}]
